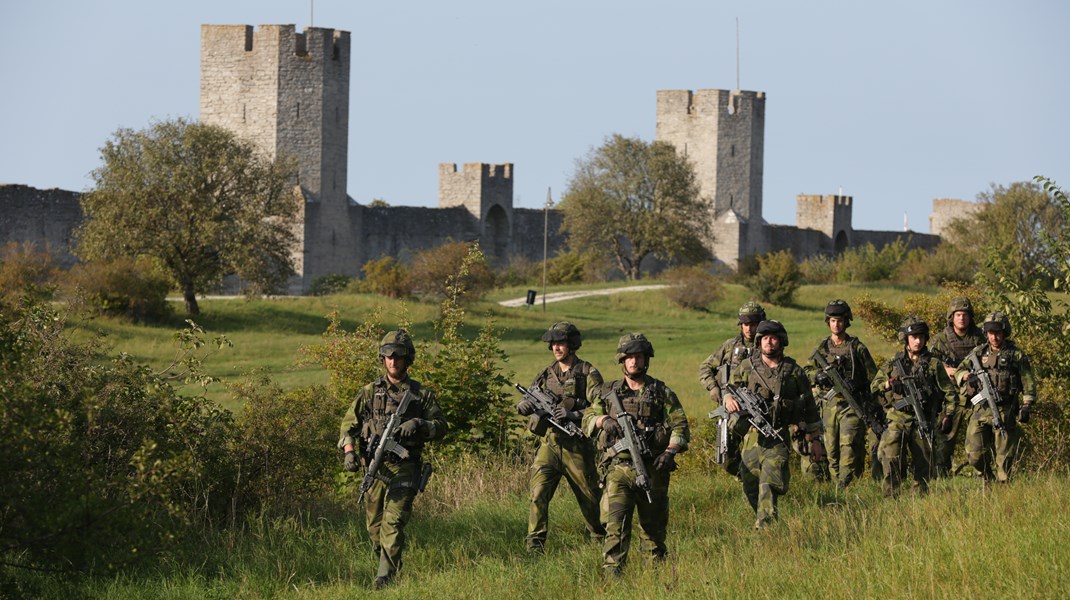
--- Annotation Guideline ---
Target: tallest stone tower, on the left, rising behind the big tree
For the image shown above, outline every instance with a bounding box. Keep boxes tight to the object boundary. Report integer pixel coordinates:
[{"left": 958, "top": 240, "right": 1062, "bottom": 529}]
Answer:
[{"left": 200, "top": 25, "right": 363, "bottom": 292}]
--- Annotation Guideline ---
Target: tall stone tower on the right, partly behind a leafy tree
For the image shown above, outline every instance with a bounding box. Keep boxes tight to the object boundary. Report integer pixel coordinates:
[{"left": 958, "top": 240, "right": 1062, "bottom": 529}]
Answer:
[{"left": 655, "top": 90, "right": 768, "bottom": 267}]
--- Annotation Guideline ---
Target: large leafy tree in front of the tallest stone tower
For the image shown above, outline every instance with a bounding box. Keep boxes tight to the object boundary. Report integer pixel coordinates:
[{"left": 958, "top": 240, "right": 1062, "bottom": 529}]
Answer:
[{"left": 77, "top": 119, "right": 299, "bottom": 314}]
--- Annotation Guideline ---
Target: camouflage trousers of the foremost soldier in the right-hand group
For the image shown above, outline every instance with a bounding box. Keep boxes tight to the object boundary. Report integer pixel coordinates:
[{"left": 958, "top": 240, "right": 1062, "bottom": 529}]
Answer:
[{"left": 739, "top": 430, "right": 791, "bottom": 528}]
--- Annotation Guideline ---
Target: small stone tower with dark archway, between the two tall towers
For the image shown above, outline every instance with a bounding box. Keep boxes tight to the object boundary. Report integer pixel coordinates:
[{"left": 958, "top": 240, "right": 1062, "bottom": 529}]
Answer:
[{"left": 439, "top": 163, "right": 513, "bottom": 263}]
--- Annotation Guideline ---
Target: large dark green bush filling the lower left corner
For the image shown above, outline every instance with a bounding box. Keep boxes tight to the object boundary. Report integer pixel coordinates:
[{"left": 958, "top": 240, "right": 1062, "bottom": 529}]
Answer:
[{"left": 0, "top": 303, "right": 232, "bottom": 571}]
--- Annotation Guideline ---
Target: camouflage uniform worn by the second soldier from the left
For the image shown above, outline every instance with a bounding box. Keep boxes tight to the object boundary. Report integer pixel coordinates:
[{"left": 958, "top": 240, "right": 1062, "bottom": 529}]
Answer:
[{"left": 524, "top": 346, "right": 606, "bottom": 552}]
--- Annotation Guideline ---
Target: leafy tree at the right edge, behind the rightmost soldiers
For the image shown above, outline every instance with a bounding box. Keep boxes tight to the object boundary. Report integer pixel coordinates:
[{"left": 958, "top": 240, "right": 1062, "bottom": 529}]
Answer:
[{"left": 947, "top": 182, "right": 1067, "bottom": 287}]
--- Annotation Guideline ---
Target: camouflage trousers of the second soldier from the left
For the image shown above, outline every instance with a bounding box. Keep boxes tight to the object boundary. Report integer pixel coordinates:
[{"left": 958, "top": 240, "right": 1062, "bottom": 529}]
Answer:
[{"left": 524, "top": 433, "right": 606, "bottom": 550}]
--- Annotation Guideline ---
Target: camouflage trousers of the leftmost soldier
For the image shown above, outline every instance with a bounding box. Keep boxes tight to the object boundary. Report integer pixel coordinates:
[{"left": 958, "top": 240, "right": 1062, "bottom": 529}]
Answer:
[{"left": 364, "top": 460, "right": 419, "bottom": 578}]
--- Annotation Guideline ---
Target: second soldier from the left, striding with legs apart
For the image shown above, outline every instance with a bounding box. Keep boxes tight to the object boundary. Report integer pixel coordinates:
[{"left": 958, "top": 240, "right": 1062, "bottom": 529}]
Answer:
[{"left": 517, "top": 321, "right": 606, "bottom": 553}]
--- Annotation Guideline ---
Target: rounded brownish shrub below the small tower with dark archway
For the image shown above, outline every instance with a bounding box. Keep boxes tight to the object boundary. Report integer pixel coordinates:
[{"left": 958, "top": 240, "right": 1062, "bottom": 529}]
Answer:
[{"left": 412, "top": 242, "right": 494, "bottom": 301}]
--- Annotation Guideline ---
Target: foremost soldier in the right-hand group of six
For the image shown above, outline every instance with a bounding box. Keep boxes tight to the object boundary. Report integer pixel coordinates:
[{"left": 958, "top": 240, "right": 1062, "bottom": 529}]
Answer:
[{"left": 724, "top": 321, "right": 825, "bottom": 529}]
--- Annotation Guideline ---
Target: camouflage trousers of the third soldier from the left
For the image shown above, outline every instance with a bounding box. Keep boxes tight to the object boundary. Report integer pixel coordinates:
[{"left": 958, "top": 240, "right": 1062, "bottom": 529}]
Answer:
[{"left": 601, "top": 460, "right": 669, "bottom": 570}]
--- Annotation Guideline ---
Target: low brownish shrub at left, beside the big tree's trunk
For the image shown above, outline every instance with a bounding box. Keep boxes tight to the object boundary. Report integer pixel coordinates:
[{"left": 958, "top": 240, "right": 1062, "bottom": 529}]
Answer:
[{"left": 64, "top": 258, "right": 172, "bottom": 322}]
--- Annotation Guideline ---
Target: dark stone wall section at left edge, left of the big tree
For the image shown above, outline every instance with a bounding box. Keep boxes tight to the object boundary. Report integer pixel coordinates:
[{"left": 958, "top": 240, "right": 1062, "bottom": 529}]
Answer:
[{"left": 0, "top": 185, "right": 81, "bottom": 267}]
